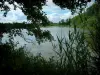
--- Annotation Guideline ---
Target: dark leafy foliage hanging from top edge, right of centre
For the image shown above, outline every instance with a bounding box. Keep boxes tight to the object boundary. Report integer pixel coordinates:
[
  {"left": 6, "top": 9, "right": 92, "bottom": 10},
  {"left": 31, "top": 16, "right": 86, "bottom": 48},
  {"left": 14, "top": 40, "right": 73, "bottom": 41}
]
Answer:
[{"left": 53, "top": 0, "right": 91, "bottom": 13}]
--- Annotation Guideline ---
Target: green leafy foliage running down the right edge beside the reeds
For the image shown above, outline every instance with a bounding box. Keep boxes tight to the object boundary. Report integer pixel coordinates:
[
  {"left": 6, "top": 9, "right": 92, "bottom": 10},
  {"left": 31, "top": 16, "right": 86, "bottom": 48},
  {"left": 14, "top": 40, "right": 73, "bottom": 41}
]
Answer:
[{"left": 67, "top": 3, "right": 100, "bottom": 75}]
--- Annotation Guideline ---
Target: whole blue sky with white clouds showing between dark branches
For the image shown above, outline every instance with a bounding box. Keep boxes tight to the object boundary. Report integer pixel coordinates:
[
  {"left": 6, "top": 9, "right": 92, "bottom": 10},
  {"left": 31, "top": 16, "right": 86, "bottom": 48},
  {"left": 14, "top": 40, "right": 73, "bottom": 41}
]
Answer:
[{"left": 0, "top": 0, "right": 93, "bottom": 23}]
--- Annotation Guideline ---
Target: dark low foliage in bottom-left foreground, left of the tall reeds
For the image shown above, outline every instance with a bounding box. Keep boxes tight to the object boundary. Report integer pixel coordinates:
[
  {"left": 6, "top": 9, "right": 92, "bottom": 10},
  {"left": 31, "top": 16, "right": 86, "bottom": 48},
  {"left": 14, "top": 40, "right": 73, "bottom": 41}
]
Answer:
[{"left": 0, "top": 44, "right": 57, "bottom": 75}]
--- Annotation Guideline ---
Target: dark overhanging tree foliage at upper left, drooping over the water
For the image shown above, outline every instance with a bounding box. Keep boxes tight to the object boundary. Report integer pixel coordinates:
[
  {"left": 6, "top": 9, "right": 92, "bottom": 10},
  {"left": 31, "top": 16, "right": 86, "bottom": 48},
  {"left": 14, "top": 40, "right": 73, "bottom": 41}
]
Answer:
[{"left": 0, "top": 0, "right": 51, "bottom": 41}]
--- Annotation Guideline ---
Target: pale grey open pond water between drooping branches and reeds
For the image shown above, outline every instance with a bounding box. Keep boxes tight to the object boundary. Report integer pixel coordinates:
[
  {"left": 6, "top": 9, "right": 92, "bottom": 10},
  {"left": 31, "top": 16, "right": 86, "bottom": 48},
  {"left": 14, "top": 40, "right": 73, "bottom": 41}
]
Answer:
[{"left": 3, "top": 27, "right": 73, "bottom": 57}]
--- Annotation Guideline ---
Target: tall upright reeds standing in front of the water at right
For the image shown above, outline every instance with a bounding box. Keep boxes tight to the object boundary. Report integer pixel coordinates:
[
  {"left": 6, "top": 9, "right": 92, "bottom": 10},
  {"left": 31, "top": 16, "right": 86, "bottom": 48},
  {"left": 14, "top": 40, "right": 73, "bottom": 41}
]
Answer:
[{"left": 54, "top": 28, "right": 94, "bottom": 75}]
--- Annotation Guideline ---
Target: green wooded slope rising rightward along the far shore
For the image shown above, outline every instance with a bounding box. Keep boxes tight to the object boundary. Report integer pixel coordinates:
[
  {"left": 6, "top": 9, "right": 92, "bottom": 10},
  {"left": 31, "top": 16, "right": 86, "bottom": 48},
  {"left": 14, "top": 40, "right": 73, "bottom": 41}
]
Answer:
[{"left": 58, "top": 3, "right": 100, "bottom": 27}]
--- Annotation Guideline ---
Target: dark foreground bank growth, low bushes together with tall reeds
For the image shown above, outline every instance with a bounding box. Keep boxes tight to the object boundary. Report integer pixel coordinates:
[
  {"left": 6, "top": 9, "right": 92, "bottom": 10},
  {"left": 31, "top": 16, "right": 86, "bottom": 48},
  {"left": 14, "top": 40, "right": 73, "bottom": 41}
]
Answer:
[{"left": 0, "top": 27, "right": 96, "bottom": 75}]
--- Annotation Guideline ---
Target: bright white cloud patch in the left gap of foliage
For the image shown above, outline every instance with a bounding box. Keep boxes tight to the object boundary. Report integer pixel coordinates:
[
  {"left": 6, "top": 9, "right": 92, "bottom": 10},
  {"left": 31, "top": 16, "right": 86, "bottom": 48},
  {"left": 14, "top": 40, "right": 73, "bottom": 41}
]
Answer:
[{"left": 0, "top": 8, "right": 26, "bottom": 23}]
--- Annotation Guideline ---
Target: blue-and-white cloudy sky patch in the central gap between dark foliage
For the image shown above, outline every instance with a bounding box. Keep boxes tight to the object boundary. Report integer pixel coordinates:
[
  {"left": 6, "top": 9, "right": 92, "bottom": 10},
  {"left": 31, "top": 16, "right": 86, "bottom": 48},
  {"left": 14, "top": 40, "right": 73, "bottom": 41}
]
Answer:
[{"left": 43, "top": 0, "right": 71, "bottom": 23}]
